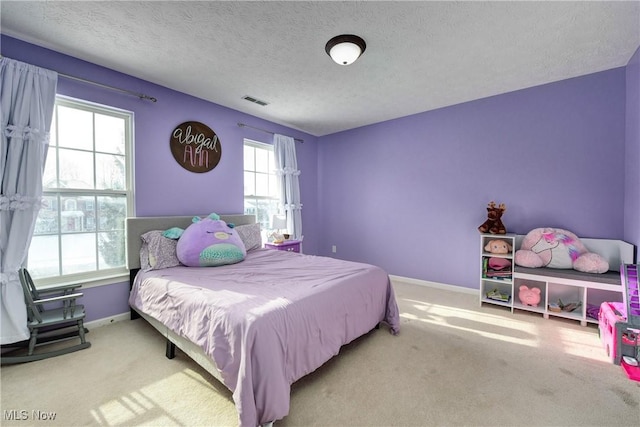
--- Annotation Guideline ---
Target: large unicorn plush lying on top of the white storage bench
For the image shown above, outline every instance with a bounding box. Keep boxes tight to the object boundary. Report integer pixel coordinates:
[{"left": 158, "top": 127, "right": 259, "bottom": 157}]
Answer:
[{"left": 514, "top": 228, "right": 609, "bottom": 273}]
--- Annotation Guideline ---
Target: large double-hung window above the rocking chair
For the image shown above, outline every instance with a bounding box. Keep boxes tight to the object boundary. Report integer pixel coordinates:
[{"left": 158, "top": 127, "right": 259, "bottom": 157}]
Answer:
[{"left": 28, "top": 97, "right": 133, "bottom": 284}]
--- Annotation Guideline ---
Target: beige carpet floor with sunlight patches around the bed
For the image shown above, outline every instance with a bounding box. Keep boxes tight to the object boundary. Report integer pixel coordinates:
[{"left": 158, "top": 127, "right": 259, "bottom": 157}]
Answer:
[{"left": 0, "top": 282, "right": 640, "bottom": 426}]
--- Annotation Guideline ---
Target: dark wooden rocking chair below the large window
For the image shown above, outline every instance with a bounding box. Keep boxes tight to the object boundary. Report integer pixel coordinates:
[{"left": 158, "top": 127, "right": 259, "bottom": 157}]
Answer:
[{"left": 0, "top": 268, "right": 91, "bottom": 365}]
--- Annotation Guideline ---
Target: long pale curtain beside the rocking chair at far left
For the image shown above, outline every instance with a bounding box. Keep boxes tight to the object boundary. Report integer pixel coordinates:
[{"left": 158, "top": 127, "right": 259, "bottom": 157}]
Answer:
[{"left": 0, "top": 58, "right": 58, "bottom": 344}]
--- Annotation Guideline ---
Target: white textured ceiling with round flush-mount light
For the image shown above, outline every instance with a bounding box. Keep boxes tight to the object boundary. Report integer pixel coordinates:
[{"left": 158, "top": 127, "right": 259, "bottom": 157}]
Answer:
[{"left": 0, "top": 0, "right": 640, "bottom": 136}]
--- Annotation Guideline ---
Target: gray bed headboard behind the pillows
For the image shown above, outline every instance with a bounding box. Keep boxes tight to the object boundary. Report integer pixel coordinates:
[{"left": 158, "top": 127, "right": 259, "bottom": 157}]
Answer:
[{"left": 126, "top": 214, "right": 256, "bottom": 270}]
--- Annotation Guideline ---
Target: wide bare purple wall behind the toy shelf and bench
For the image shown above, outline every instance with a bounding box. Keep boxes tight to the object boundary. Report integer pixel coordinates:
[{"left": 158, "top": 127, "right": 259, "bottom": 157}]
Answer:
[{"left": 318, "top": 68, "right": 637, "bottom": 288}]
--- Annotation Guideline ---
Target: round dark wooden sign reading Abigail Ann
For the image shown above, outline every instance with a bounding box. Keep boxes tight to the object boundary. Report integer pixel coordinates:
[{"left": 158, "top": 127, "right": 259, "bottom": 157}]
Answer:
[{"left": 169, "top": 122, "right": 222, "bottom": 173}]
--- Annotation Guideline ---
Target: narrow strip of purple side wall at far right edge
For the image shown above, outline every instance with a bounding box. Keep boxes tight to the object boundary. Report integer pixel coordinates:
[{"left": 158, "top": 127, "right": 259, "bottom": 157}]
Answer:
[{"left": 624, "top": 47, "right": 640, "bottom": 254}]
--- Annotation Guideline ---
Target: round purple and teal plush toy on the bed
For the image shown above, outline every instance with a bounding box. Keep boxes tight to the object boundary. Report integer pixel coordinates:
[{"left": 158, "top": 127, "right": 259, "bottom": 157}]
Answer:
[{"left": 164, "top": 213, "right": 247, "bottom": 267}]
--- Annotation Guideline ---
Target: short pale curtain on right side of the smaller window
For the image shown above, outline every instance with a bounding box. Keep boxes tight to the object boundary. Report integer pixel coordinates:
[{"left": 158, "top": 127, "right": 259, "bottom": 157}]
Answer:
[{"left": 273, "top": 134, "right": 302, "bottom": 240}]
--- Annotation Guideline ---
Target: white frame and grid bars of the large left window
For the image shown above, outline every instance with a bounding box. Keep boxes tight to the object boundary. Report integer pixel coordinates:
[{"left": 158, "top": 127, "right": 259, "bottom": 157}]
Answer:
[{"left": 27, "top": 95, "right": 135, "bottom": 288}]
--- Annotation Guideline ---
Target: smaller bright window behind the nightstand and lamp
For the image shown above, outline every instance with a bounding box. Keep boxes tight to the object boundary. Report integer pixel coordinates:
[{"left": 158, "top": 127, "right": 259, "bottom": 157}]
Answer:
[{"left": 244, "top": 139, "right": 280, "bottom": 234}]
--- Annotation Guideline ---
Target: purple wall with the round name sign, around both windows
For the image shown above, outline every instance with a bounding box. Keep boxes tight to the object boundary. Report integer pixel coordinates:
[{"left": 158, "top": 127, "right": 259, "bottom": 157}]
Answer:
[{"left": 1, "top": 36, "right": 318, "bottom": 320}]
